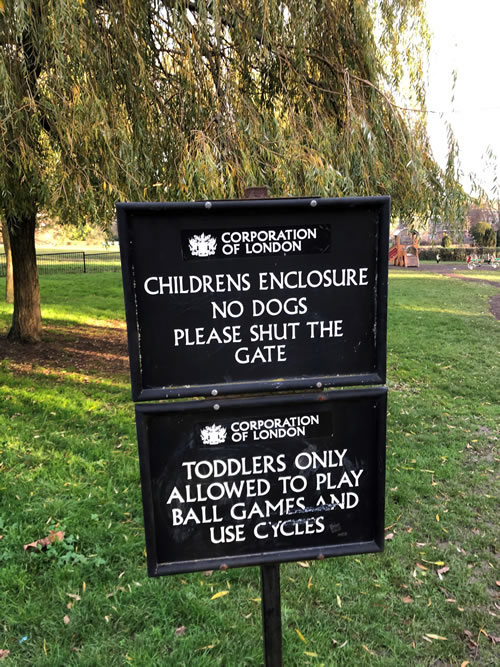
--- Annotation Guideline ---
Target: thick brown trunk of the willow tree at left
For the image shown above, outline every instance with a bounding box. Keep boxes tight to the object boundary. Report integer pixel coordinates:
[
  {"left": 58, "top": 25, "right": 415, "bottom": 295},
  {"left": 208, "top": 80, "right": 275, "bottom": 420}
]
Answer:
[{"left": 7, "top": 211, "right": 42, "bottom": 343}]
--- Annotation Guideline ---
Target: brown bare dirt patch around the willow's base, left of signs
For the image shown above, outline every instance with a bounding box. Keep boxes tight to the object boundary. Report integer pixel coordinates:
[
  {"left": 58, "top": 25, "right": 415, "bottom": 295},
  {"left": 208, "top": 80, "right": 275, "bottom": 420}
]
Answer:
[{"left": 0, "top": 320, "right": 129, "bottom": 377}]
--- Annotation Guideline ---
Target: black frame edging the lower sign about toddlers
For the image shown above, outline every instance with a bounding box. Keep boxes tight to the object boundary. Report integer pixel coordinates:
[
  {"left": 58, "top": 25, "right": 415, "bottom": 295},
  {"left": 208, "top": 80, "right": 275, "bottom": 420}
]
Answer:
[{"left": 136, "top": 387, "right": 387, "bottom": 576}]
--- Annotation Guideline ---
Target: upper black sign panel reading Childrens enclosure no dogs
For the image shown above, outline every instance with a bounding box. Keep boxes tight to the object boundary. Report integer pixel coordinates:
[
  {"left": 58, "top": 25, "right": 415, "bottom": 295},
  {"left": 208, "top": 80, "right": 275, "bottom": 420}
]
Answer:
[{"left": 118, "top": 197, "right": 389, "bottom": 401}]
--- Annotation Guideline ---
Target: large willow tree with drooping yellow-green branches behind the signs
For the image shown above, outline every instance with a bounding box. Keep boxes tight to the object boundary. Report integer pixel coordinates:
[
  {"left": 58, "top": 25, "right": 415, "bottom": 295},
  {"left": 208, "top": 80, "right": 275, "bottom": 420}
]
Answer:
[{"left": 0, "top": 0, "right": 460, "bottom": 341}]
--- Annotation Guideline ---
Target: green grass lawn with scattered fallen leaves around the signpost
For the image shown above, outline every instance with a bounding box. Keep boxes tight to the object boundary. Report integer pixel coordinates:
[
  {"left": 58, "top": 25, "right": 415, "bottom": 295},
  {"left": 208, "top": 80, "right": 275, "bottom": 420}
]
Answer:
[{"left": 0, "top": 271, "right": 500, "bottom": 667}]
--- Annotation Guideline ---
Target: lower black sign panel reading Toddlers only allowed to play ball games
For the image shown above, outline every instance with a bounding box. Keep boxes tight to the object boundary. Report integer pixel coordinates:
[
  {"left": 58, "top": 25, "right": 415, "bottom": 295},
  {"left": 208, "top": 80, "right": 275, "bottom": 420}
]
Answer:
[{"left": 136, "top": 388, "right": 386, "bottom": 576}]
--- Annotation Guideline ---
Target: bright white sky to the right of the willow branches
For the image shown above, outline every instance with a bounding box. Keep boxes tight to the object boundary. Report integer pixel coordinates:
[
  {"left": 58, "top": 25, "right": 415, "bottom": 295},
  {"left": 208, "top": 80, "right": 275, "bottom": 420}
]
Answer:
[{"left": 427, "top": 0, "right": 500, "bottom": 196}]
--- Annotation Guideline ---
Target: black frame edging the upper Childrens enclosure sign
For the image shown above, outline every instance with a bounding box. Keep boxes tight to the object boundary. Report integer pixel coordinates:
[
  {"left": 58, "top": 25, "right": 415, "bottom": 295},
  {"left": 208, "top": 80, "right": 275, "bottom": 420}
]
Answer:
[{"left": 117, "top": 197, "right": 390, "bottom": 401}]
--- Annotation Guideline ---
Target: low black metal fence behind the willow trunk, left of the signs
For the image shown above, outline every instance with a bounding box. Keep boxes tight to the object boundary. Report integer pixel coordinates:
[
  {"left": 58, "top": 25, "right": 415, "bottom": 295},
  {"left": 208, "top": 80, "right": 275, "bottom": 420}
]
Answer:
[{"left": 0, "top": 251, "right": 121, "bottom": 277}]
